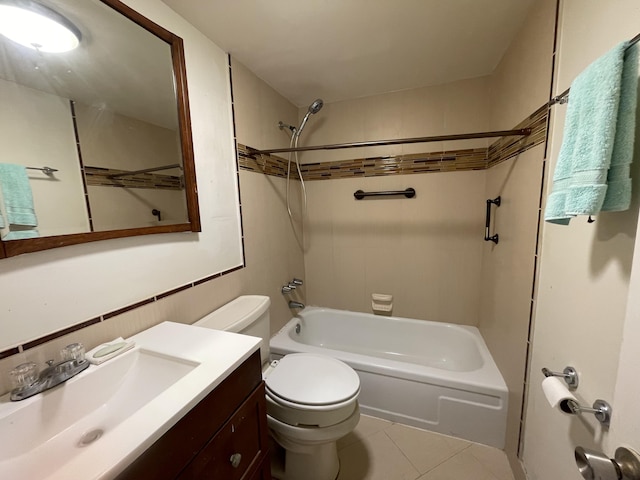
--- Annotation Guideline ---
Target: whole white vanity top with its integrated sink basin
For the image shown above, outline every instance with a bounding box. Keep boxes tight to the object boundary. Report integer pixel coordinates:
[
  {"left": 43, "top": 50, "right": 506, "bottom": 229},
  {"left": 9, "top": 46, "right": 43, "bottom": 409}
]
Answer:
[{"left": 0, "top": 322, "right": 260, "bottom": 480}]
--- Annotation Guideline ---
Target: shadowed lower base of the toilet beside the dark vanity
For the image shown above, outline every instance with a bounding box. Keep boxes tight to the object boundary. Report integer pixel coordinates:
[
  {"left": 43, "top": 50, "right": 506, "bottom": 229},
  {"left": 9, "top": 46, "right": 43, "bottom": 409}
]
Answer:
[{"left": 271, "top": 442, "right": 340, "bottom": 480}]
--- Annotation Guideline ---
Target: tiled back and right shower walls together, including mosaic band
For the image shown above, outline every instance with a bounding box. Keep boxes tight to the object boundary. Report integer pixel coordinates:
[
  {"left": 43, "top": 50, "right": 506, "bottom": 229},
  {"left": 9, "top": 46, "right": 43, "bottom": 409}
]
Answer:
[{"left": 240, "top": 0, "right": 555, "bottom": 478}]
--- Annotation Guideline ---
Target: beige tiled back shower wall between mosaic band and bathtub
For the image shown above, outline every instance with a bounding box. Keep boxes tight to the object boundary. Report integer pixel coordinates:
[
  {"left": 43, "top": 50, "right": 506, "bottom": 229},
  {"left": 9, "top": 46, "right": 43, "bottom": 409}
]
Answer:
[{"left": 305, "top": 171, "right": 485, "bottom": 325}]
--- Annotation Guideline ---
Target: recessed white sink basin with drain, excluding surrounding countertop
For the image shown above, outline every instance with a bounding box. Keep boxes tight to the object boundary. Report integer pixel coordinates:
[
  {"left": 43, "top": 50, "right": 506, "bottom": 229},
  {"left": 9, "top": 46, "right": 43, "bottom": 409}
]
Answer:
[{"left": 0, "top": 347, "right": 199, "bottom": 480}]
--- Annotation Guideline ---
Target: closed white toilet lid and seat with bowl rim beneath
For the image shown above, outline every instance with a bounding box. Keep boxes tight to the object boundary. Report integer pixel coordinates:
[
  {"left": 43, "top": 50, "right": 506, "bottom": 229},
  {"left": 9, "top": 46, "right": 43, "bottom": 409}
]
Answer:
[{"left": 265, "top": 353, "right": 360, "bottom": 427}]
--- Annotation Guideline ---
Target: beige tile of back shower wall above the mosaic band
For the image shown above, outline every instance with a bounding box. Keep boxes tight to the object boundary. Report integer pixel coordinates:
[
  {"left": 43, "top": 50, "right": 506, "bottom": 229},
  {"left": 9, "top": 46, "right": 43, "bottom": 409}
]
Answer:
[{"left": 298, "top": 77, "right": 490, "bottom": 163}]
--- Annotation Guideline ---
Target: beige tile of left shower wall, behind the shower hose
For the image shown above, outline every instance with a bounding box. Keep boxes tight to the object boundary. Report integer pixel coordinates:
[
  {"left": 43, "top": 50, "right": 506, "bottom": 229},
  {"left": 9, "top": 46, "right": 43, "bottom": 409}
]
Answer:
[{"left": 232, "top": 57, "right": 306, "bottom": 333}]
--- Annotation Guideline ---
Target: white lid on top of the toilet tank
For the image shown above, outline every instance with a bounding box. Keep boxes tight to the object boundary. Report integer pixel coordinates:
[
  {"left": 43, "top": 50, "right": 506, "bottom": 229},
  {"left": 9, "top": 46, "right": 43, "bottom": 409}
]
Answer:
[{"left": 194, "top": 295, "right": 271, "bottom": 333}]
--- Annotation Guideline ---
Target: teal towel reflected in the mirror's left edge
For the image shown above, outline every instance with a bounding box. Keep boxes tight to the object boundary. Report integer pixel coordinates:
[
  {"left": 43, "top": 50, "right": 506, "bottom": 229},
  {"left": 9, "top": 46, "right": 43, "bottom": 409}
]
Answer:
[{"left": 0, "top": 163, "right": 38, "bottom": 227}]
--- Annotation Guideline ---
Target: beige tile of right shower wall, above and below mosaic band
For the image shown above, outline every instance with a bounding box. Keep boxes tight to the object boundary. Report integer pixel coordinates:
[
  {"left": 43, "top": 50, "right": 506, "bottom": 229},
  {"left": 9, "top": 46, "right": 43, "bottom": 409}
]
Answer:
[{"left": 478, "top": 0, "right": 559, "bottom": 480}]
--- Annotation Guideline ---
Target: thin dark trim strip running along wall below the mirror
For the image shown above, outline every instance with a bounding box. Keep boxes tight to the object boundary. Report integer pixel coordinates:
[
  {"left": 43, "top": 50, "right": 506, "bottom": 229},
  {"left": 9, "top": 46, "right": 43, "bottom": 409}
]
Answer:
[{"left": 0, "top": 265, "right": 244, "bottom": 360}]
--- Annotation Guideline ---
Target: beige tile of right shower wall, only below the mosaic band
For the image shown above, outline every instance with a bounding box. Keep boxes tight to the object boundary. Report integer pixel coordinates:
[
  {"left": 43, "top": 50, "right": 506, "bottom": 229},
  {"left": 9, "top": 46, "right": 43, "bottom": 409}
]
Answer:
[{"left": 478, "top": 145, "right": 544, "bottom": 460}]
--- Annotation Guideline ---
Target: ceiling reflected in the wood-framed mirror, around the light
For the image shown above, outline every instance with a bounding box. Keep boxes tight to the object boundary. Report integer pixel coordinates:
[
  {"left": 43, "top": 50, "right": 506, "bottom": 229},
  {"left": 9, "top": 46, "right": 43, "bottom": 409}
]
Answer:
[{"left": 0, "top": 0, "right": 178, "bottom": 130}]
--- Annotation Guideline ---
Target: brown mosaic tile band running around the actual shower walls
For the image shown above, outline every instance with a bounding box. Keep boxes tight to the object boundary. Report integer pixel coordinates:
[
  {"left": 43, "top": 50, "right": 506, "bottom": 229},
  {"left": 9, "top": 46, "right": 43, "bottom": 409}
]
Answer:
[{"left": 238, "top": 104, "right": 548, "bottom": 180}]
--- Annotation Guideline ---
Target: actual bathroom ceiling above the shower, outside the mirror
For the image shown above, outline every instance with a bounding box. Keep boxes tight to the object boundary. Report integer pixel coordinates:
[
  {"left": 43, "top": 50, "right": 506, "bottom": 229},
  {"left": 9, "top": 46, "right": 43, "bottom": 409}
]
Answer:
[{"left": 163, "top": 0, "right": 534, "bottom": 106}]
